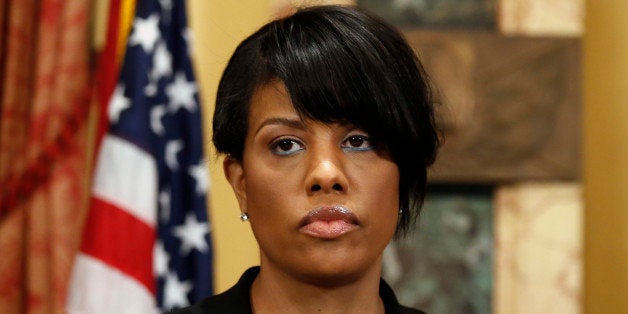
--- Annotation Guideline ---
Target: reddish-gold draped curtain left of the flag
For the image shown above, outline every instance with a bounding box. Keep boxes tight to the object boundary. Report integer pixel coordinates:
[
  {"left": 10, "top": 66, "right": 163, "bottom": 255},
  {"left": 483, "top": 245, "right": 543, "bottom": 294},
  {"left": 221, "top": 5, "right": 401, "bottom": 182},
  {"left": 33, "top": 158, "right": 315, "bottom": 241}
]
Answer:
[{"left": 0, "top": 0, "right": 91, "bottom": 313}]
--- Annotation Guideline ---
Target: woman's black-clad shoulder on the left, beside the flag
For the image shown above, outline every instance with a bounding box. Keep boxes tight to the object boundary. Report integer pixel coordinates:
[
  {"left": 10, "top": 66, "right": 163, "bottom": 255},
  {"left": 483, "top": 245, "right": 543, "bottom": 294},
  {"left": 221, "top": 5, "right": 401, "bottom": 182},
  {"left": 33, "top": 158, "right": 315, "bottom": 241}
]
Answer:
[{"left": 164, "top": 267, "right": 259, "bottom": 314}]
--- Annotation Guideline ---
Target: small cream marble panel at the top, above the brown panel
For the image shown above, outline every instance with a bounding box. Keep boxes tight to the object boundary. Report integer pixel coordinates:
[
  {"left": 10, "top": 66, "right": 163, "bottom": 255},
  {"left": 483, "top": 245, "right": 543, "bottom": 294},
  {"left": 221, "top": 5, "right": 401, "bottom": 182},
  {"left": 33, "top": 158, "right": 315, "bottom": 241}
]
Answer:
[{"left": 497, "top": 0, "right": 585, "bottom": 36}]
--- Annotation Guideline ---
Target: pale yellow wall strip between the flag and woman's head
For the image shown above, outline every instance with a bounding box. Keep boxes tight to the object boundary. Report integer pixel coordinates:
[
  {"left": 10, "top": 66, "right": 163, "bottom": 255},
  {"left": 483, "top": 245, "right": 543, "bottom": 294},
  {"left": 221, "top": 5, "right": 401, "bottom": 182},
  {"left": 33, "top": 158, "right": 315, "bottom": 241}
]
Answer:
[{"left": 188, "top": 0, "right": 270, "bottom": 292}]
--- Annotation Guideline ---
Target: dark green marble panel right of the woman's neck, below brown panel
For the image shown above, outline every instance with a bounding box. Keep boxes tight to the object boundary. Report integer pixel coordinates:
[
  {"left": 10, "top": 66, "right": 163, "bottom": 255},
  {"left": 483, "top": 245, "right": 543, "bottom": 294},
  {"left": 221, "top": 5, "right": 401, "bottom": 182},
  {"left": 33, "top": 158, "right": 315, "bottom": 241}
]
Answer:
[{"left": 383, "top": 187, "right": 493, "bottom": 314}]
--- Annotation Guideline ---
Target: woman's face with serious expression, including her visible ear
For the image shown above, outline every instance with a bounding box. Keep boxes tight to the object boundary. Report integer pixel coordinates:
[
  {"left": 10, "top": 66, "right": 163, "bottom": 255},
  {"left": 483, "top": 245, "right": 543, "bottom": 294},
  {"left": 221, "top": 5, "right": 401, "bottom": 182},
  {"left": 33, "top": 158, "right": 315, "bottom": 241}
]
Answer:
[{"left": 225, "top": 82, "right": 399, "bottom": 285}]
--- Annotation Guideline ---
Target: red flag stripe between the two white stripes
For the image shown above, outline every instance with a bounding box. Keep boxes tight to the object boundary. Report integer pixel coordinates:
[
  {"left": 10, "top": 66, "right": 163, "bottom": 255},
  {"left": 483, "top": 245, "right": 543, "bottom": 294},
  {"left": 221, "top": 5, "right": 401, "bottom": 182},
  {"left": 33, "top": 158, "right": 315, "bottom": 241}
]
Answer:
[{"left": 81, "top": 197, "right": 156, "bottom": 294}]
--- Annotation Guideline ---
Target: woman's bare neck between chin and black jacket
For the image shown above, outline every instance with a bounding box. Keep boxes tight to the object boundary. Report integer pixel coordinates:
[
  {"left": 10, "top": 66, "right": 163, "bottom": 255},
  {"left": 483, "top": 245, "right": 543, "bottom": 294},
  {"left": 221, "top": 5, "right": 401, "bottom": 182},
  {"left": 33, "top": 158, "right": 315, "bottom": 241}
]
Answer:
[{"left": 251, "top": 258, "right": 385, "bottom": 314}]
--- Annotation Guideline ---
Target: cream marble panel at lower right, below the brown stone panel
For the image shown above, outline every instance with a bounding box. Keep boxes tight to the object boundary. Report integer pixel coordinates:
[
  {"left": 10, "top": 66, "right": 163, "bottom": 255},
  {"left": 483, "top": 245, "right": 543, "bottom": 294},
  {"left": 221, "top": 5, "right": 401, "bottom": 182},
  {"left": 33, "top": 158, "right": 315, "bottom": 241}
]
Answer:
[{"left": 493, "top": 182, "right": 583, "bottom": 314}]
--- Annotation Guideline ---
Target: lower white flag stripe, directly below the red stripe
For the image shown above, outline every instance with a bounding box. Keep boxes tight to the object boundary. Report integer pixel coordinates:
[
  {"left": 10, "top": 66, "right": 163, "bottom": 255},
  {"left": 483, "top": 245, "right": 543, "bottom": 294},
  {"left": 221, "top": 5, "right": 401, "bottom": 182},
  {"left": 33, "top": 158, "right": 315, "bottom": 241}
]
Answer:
[{"left": 67, "top": 254, "right": 157, "bottom": 314}]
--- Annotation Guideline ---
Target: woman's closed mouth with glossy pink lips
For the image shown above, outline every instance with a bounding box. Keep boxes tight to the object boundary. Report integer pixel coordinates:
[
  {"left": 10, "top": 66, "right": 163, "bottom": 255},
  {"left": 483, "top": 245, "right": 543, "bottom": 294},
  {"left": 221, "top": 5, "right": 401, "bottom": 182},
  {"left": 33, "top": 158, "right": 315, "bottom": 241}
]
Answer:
[{"left": 299, "top": 206, "right": 360, "bottom": 240}]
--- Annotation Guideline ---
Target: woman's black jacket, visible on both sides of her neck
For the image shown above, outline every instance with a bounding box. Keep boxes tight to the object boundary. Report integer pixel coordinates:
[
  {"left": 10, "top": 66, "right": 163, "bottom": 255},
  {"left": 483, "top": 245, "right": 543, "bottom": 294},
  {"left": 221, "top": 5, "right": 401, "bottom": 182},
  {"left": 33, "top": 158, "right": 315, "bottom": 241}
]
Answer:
[{"left": 170, "top": 267, "right": 425, "bottom": 314}]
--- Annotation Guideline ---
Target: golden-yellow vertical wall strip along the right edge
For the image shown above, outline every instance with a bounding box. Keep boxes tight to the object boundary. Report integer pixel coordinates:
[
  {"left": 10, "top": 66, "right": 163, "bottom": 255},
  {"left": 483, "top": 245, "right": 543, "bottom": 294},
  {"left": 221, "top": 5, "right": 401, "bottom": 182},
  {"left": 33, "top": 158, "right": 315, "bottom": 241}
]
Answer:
[{"left": 583, "top": 0, "right": 628, "bottom": 313}]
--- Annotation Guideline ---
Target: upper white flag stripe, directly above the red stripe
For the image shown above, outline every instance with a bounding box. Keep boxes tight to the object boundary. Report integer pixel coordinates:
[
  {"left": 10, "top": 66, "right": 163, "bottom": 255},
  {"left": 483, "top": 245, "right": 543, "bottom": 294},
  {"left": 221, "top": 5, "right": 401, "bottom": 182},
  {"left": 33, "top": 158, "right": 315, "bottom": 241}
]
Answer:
[{"left": 93, "top": 134, "right": 158, "bottom": 227}]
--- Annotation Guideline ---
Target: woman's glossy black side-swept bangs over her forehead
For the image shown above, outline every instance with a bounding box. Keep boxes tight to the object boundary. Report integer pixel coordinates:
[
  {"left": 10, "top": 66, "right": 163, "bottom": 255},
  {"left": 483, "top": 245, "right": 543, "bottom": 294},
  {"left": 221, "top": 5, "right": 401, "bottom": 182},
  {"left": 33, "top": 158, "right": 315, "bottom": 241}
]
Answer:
[{"left": 261, "top": 10, "right": 410, "bottom": 146}]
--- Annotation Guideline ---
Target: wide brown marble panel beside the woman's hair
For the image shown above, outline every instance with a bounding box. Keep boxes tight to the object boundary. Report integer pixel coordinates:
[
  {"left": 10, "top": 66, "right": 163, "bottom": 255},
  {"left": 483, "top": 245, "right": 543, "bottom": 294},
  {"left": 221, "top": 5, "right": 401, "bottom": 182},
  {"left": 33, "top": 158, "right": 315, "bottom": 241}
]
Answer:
[{"left": 405, "top": 29, "right": 581, "bottom": 183}]
